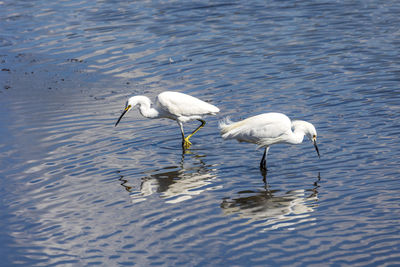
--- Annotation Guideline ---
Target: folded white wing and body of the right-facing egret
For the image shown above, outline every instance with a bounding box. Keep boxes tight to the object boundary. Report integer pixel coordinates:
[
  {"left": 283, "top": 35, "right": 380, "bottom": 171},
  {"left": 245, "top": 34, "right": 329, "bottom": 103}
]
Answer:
[{"left": 222, "top": 113, "right": 291, "bottom": 144}]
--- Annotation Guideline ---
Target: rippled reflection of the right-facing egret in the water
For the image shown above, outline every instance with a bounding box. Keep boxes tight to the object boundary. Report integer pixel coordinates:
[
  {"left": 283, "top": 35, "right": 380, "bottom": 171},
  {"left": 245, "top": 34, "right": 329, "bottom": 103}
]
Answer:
[{"left": 221, "top": 173, "right": 321, "bottom": 230}]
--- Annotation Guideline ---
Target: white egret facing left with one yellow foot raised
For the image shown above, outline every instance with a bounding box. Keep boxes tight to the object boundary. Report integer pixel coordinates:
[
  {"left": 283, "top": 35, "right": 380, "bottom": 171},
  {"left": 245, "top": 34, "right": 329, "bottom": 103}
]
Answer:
[{"left": 115, "top": 92, "right": 219, "bottom": 149}]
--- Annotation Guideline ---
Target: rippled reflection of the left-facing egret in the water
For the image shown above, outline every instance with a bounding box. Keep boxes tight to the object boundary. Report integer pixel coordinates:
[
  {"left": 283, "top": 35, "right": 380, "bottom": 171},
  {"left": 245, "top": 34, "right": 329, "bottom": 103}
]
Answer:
[{"left": 119, "top": 151, "right": 216, "bottom": 203}]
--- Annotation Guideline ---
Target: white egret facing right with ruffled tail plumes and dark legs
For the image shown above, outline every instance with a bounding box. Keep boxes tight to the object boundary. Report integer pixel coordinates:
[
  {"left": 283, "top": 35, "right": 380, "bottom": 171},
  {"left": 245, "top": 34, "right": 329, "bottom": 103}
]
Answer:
[{"left": 219, "top": 113, "right": 320, "bottom": 170}]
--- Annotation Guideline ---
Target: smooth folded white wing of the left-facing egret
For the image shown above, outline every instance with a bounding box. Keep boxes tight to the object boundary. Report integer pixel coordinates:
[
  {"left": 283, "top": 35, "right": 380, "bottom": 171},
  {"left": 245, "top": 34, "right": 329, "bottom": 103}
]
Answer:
[{"left": 157, "top": 92, "right": 219, "bottom": 117}]
